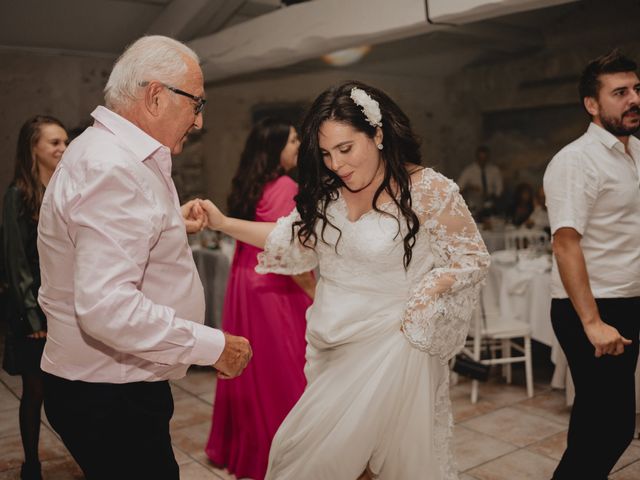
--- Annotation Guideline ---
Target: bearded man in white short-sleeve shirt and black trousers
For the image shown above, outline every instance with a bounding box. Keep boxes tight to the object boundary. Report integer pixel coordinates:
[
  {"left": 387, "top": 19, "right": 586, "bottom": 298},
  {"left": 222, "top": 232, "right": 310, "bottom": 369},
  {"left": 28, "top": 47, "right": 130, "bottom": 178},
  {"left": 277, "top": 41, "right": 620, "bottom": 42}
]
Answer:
[{"left": 544, "top": 50, "right": 640, "bottom": 480}]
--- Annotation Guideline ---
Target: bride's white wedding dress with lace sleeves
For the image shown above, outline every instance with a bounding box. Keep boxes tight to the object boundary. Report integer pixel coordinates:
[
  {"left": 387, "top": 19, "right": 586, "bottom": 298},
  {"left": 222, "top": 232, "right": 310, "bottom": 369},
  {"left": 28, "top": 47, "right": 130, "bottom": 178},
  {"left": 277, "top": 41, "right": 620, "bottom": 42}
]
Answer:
[{"left": 256, "top": 169, "right": 489, "bottom": 480}]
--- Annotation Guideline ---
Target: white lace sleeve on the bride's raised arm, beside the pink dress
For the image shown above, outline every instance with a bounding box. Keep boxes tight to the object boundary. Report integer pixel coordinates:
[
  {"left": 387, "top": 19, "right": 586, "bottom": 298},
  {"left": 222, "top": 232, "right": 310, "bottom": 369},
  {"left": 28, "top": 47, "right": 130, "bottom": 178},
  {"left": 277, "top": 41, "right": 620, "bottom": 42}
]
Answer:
[{"left": 256, "top": 209, "right": 318, "bottom": 275}]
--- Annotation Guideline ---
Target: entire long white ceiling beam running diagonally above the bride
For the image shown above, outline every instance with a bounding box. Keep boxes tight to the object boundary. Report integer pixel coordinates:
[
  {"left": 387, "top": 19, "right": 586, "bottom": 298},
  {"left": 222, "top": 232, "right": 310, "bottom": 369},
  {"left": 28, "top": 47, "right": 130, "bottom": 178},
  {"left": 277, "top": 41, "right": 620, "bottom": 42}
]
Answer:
[{"left": 189, "top": 0, "right": 576, "bottom": 82}]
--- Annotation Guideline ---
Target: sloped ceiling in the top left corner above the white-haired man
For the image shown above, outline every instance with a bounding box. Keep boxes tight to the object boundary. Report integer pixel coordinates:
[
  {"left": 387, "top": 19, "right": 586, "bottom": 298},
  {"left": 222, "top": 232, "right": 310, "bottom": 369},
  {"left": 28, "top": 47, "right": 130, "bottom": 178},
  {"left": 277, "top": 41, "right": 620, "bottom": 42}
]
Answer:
[{"left": 0, "top": 0, "right": 281, "bottom": 56}]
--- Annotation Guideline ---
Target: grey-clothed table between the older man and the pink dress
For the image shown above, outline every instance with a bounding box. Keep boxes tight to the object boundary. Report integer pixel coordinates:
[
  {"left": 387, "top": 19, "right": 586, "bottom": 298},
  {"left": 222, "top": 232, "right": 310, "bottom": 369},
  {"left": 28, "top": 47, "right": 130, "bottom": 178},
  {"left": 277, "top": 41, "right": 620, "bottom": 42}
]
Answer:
[{"left": 191, "top": 245, "right": 231, "bottom": 328}]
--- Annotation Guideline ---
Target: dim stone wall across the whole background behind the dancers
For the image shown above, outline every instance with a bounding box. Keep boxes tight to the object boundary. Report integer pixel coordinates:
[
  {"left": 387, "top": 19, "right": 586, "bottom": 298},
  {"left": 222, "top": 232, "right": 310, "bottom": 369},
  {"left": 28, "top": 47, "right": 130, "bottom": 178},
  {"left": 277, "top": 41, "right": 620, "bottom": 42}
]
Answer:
[{"left": 0, "top": 0, "right": 640, "bottom": 214}]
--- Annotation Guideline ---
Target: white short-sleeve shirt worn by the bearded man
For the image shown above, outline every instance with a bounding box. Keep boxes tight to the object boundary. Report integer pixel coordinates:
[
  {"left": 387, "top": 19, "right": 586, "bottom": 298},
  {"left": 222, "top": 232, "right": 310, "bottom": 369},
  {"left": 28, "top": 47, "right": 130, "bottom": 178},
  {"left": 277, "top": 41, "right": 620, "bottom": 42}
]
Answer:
[{"left": 544, "top": 123, "right": 640, "bottom": 298}]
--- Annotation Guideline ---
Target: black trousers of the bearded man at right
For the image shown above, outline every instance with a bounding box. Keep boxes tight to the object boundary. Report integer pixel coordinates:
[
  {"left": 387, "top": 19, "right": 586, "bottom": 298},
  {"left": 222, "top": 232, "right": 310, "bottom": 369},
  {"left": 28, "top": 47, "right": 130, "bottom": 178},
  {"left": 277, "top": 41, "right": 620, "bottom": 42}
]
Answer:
[{"left": 551, "top": 297, "right": 640, "bottom": 480}]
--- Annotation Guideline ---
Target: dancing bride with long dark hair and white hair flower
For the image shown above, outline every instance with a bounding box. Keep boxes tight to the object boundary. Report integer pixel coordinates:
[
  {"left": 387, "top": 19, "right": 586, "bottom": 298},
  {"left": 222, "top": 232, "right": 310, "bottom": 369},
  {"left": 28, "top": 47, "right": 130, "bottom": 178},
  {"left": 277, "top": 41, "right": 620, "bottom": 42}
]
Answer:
[{"left": 203, "top": 82, "right": 489, "bottom": 480}]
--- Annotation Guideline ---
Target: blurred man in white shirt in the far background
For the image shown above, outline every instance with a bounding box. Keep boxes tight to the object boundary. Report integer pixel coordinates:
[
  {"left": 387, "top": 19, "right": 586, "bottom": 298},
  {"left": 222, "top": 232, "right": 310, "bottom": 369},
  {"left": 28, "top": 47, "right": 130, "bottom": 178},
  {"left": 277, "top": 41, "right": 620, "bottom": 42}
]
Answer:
[{"left": 457, "top": 145, "right": 503, "bottom": 217}]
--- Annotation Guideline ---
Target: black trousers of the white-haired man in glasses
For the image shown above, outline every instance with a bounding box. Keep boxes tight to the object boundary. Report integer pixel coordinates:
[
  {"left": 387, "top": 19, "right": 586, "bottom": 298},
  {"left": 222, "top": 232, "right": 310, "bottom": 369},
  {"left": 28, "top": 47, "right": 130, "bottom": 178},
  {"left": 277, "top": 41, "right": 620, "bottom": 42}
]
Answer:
[{"left": 44, "top": 374, "right": 179, "bottom": 480}]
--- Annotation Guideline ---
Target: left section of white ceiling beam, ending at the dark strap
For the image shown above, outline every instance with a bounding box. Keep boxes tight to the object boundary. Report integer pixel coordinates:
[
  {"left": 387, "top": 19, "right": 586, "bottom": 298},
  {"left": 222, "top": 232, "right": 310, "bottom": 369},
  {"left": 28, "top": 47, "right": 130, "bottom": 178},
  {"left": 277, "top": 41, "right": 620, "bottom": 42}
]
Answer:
[{"left": 189, "top": 0, "right": 442, "bottom": 81}]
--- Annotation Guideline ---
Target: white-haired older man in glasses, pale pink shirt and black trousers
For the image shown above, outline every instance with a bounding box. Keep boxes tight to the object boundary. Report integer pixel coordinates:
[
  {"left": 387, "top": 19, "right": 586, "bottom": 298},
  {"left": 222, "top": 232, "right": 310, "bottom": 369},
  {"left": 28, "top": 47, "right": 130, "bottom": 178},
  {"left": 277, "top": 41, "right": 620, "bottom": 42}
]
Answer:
[{"left": 38, "top": 36, "right": 251, "bottom": 480}]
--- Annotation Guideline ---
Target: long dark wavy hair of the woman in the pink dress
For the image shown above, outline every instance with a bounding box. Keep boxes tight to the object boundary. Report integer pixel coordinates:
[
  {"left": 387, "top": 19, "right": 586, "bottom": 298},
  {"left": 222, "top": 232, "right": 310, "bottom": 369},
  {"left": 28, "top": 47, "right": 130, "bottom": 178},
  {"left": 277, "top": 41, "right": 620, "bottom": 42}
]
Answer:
[{"left": 227, "top": 118, "right": 292, "bottom": 220}]
